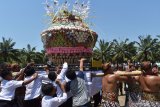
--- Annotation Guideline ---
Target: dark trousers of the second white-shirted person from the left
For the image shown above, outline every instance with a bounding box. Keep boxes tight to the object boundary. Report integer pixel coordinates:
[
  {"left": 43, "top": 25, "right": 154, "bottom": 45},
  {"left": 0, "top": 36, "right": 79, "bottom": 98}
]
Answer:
[{"left": 24, "top": 97, "right": 42, "bottom": 107}]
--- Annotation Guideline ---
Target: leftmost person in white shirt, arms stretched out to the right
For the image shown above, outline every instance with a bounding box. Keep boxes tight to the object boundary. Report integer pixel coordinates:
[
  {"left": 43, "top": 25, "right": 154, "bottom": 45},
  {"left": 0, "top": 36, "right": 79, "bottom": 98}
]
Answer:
[{"left": 0, "top": 70, "right": 37, "bottom": 107}]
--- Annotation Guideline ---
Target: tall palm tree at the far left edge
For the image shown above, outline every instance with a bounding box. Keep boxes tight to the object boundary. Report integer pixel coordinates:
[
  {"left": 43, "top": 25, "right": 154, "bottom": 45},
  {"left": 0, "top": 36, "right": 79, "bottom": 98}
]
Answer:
[{"left": 0, "top": 37, "right": 19, "bottom": 62}]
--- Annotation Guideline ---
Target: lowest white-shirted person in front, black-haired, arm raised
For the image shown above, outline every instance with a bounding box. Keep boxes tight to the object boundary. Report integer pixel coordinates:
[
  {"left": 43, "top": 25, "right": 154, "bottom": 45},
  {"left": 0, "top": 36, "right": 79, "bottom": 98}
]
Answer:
[{"left": 42, "top": 83, "right": 67, "bottom": 107}]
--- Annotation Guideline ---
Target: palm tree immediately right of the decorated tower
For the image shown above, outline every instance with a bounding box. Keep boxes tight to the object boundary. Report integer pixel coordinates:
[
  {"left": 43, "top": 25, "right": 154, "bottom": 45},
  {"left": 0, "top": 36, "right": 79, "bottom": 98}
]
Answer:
[{"left": 93, "top": 40, "right": 112, "bottom": 63}]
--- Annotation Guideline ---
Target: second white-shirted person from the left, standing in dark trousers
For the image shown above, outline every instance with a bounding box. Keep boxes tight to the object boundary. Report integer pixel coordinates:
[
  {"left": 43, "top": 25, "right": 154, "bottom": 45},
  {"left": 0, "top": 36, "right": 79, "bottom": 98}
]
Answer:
[{"left": 24, "top": 66, "right": 48, "bottom": 107}]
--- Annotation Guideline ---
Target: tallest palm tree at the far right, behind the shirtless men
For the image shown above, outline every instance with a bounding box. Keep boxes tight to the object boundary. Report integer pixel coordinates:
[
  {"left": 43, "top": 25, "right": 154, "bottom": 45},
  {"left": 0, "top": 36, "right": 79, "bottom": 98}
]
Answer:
[{"left": 136, "top": 35, "right": 159, "bottom": 62}]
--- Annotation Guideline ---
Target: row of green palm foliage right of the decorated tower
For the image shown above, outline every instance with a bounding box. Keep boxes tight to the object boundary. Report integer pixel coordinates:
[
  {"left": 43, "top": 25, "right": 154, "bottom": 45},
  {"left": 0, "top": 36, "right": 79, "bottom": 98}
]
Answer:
[{"left": 93, "top": 35, "right": 160, "bottom": 64}]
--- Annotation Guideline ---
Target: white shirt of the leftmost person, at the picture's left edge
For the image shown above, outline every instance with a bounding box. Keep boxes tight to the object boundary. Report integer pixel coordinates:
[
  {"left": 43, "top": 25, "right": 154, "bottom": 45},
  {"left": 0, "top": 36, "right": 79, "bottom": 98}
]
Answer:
[{"left": 0, "top": 80, "right": 23, "bottom": 101}]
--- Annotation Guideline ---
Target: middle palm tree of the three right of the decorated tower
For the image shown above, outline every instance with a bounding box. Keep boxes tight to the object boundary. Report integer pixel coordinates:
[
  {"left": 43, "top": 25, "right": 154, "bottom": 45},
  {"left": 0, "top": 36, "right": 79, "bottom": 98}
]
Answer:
[{"left": 113, "top": 39, "right": 136, "bottom": 64}]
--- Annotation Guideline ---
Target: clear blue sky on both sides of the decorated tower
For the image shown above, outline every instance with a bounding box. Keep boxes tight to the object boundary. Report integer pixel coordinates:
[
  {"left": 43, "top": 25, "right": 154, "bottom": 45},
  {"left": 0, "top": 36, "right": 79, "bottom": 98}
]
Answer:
[{"left": 0, "top": 0, "right": 160, "bottom": 50}]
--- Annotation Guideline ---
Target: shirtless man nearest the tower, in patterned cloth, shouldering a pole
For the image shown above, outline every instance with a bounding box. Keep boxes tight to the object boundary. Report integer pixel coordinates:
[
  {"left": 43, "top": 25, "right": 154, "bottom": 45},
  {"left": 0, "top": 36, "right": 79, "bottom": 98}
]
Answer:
[{"left": 102, "top": 63, "right": 126, "bottom": 107}]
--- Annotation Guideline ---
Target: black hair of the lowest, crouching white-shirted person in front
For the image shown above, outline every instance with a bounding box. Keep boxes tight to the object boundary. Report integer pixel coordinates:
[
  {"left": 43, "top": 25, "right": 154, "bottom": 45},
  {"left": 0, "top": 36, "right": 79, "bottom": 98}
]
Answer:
[{"left": 42, "top": 83, "right": 56, "bottom": 95}]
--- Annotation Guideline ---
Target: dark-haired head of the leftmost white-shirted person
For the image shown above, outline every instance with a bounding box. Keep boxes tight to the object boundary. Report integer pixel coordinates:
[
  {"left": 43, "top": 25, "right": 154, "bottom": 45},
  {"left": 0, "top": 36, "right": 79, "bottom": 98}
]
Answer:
[{"left": 1, "top": 69, "right": 13, "bottom": 80}]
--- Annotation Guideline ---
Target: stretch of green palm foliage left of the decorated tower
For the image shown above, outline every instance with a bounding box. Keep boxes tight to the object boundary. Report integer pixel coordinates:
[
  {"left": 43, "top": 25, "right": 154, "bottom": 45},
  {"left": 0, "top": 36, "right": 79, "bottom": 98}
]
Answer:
[{"left": 0, "top": 37, "right": 45, "bottom": 66}]
